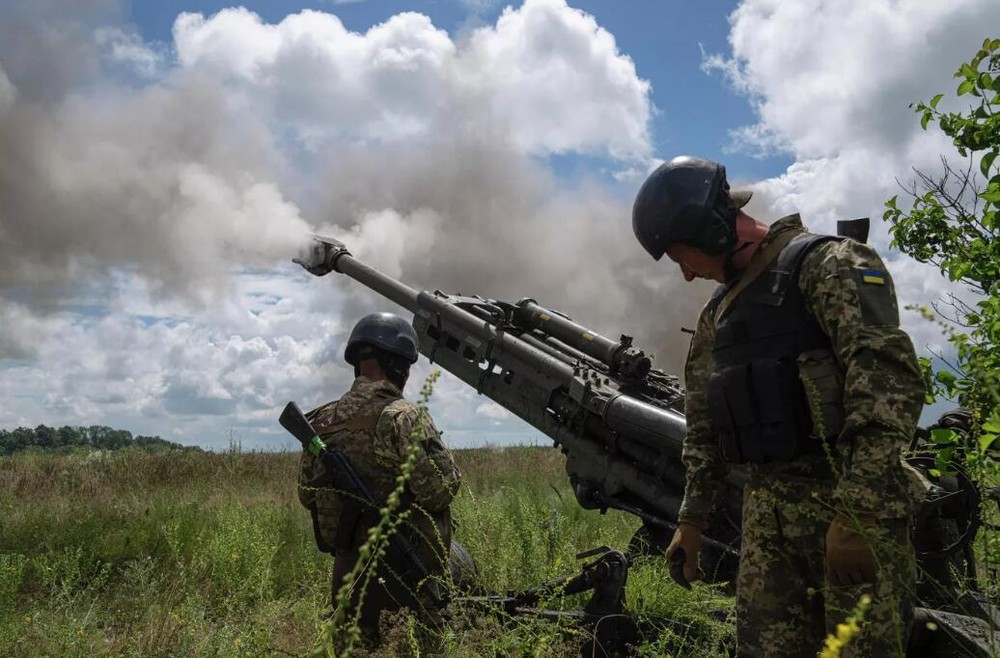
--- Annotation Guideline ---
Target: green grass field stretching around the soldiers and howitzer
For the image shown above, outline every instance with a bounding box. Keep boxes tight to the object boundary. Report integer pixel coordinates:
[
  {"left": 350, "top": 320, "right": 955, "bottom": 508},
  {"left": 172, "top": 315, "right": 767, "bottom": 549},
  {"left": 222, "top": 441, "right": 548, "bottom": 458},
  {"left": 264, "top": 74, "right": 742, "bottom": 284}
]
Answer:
[{"left": 0, "top": 448, "right": 732, "bottom": 656}]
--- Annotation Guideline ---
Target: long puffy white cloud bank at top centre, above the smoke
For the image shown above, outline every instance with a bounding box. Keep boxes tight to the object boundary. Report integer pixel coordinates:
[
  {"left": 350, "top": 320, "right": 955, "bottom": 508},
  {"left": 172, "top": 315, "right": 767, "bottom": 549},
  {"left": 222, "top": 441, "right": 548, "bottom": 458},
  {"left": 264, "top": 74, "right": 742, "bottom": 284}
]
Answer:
[{"left": 174, "top": 0, "right": 651, "bottom": 157}]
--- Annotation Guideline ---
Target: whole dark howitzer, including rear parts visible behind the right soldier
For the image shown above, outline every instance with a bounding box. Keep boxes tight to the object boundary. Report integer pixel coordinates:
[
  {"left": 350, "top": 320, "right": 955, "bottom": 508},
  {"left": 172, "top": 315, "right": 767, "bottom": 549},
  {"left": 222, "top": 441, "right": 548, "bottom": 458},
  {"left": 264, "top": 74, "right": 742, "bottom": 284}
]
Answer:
[{"left": 294, "top": 237, "right": 1000, "bottom": 655}]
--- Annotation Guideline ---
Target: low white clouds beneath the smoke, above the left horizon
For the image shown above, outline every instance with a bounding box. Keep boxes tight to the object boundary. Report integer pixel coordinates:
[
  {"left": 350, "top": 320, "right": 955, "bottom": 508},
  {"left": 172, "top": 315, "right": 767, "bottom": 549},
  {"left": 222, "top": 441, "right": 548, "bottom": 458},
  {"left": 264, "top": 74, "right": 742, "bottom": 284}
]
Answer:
[{"left": 0, "top": 268, "right": 352, "bottom": 447}]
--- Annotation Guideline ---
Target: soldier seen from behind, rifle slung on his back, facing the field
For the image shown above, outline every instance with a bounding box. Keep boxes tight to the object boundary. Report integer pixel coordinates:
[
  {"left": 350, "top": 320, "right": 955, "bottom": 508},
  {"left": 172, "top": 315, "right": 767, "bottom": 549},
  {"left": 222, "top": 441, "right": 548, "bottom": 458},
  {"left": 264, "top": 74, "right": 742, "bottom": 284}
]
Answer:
[{"left": 298, "top": 313, "right": 460, "bottom": 642}]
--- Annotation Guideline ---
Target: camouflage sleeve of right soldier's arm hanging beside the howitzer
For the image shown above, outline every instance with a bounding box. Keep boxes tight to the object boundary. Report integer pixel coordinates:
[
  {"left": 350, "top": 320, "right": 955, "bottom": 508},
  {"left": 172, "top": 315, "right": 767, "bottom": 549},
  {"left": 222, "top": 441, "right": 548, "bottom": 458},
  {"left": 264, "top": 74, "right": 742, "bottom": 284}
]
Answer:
[{"left": 679, "top": 305, "right": 728, "bottom": 524}]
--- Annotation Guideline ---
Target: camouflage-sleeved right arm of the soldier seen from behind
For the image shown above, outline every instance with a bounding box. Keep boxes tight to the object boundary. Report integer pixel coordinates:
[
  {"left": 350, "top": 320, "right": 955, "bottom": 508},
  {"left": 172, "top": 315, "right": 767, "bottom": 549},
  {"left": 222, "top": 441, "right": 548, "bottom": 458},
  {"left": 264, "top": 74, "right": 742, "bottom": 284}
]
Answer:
[{"left": 376, "top": 402, "right": 461, "bottom": 512}]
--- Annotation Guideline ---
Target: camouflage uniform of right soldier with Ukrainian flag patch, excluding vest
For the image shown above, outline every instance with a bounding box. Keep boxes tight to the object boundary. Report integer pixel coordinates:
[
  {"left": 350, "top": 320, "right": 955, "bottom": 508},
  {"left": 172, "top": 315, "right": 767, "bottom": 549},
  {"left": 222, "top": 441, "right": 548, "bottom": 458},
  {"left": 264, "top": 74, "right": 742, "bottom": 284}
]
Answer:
[{"left": 680, "top": 215, "right": 924, "bottom": 655}]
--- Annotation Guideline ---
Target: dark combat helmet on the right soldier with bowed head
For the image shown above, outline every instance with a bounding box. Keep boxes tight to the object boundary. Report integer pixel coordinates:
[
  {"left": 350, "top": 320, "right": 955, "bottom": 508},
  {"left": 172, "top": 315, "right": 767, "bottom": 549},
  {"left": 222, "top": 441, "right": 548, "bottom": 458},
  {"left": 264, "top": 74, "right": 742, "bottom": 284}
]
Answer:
[{"left": 632, "top": 156, "right": 751, "bottom": 260}]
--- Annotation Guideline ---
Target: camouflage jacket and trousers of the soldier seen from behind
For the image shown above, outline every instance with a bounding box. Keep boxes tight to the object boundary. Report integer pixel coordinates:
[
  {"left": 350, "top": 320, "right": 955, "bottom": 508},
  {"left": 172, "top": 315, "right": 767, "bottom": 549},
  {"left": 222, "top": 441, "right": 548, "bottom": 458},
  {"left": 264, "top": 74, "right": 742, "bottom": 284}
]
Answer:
[{"left": 298, "top": 377, "right": 461, "bottom": 636}]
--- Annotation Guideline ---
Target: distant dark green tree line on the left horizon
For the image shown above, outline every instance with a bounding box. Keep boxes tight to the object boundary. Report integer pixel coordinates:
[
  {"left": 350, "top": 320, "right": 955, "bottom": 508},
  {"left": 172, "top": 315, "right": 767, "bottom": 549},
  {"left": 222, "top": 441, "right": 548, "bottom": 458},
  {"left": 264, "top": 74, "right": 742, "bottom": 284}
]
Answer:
[{"left": 0, "top": 425, "right": 201, "bottom": 455}]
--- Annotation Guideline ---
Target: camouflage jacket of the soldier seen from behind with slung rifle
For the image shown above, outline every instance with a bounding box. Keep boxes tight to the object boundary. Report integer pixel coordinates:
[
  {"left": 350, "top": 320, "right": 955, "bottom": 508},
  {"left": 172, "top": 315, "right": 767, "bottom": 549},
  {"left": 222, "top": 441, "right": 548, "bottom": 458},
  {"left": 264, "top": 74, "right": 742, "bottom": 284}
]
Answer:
[{"left": 299, "top": 377, "right": 461, "bottom": 553}]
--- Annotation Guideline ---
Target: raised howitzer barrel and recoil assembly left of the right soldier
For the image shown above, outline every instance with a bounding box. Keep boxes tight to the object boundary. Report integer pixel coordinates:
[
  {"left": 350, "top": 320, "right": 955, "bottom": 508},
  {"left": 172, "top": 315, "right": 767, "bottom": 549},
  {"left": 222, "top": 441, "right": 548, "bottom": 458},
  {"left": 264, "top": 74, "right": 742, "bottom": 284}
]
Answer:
[{"left": 295, "top": 237, "right": 745, "bottom": 580}]
